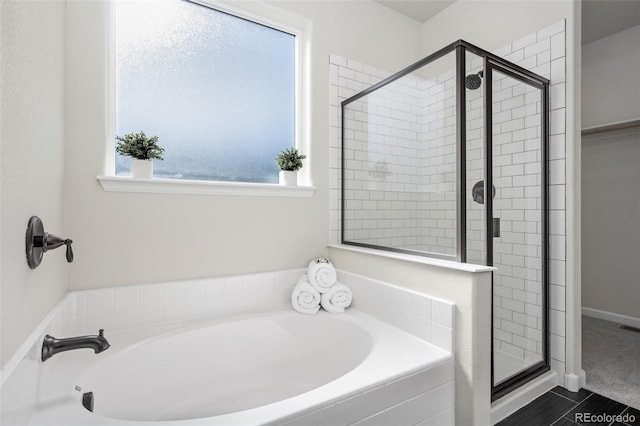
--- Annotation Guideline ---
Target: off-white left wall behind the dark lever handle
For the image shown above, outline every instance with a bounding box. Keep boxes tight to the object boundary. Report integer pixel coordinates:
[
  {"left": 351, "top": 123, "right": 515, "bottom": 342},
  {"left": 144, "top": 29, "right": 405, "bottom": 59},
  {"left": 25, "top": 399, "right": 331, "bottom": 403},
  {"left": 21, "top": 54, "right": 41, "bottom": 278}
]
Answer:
[{"left": 0, "top": 1, "right": 68, "bottom": 368}]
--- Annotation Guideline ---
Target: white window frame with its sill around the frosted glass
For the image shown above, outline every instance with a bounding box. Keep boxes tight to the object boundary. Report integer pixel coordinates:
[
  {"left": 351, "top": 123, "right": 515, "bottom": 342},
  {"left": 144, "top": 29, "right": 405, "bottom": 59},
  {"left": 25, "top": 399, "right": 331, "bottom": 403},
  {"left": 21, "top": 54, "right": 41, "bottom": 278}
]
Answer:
[{"left": 98, "top": 0, "right": 315, "bottom": 197}]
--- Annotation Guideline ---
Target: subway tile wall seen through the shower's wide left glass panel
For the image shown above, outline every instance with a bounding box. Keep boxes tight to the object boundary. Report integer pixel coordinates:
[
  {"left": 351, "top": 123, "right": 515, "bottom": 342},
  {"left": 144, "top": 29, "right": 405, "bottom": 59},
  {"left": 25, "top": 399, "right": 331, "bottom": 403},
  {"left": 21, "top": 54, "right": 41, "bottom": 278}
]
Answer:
[{"left": 338, "top": 55, "right": 456, "bottom": 255}]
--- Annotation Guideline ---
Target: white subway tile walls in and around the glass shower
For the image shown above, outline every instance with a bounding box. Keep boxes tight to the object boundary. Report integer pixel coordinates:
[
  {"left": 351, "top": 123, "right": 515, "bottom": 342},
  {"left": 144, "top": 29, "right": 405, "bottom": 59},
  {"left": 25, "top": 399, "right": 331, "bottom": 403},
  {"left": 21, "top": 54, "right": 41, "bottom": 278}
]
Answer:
[{"left": 329, "top": 21, "right": 566, "bottom": 377}]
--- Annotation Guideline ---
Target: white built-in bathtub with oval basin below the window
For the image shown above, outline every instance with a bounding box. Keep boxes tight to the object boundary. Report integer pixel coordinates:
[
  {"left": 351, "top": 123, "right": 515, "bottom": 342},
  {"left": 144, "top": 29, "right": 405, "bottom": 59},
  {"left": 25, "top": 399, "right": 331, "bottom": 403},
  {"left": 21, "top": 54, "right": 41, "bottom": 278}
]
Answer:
[{"left": 30, "top": 309, "right": 454, "bottom": 426}]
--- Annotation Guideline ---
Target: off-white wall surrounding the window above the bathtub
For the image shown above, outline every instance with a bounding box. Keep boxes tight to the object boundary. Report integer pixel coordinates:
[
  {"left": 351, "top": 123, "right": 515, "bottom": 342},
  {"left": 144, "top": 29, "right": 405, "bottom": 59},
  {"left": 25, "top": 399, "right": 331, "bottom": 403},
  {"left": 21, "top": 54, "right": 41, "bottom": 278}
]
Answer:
[{"left": 65, "top": 1, "right": 420, "bottom": 289}]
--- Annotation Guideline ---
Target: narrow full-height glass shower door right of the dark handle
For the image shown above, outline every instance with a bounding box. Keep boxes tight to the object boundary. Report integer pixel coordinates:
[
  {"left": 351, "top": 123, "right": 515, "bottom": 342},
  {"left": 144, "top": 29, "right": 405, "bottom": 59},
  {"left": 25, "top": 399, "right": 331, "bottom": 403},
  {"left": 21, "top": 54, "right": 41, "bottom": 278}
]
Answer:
[{"left": 485, "top": 63, "right": 548, "bottom": 392}]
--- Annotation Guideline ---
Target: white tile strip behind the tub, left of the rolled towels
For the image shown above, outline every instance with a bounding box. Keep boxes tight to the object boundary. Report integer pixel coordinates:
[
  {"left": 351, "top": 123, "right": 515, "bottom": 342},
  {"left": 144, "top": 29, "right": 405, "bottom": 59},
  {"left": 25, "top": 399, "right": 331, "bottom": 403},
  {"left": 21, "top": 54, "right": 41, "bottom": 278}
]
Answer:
[{"left": 64, "top": 268, "right": 304, "bottom": 334}]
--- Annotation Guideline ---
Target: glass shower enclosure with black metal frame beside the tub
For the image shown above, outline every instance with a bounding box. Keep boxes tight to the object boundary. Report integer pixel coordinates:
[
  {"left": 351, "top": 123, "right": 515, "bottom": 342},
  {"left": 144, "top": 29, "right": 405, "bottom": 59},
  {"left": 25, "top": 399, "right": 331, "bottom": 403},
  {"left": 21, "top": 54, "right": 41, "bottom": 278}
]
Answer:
[{"left": 340, "top": 40, "right": 549, "bottom": 399}]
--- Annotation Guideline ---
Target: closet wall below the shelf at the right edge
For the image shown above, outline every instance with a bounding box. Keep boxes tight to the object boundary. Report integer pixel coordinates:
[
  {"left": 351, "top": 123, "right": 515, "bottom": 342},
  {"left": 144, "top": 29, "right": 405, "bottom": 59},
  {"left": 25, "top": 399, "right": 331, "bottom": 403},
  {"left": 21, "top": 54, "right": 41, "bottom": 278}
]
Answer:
[{"left": 582, "top": 129, "right": 640, "bottom": 321}]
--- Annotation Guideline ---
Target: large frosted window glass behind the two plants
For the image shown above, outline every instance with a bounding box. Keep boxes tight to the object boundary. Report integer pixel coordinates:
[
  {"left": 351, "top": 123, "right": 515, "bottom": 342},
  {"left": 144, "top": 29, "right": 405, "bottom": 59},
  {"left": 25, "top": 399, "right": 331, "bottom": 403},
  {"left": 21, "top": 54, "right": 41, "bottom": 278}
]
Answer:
[{"left": 116, "top": 0, "right": 295, "bottom": 182}]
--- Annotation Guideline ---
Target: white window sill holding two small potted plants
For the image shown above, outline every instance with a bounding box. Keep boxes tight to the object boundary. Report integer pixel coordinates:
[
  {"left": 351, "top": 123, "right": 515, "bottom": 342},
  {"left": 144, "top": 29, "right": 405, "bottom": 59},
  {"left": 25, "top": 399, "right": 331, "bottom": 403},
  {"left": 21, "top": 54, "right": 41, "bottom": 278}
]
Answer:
[{"left": 97, "top": 176, "right": 316, "bottom": 197}]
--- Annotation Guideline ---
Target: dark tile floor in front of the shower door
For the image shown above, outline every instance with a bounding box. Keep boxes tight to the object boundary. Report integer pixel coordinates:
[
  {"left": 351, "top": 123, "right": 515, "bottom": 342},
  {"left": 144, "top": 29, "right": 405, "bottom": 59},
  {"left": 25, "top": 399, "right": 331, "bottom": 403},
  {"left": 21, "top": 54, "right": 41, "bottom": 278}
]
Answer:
[{"left": 497, "top": 386, "right": 640, "bottom": 426}]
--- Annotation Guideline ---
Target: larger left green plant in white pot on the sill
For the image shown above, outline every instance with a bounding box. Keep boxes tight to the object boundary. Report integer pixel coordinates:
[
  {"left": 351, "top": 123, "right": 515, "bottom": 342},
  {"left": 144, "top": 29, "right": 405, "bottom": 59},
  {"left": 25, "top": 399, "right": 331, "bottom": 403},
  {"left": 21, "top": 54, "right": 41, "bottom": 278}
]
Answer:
[{"left": 116, "top": 131, "right": 164, "bottom": 179}]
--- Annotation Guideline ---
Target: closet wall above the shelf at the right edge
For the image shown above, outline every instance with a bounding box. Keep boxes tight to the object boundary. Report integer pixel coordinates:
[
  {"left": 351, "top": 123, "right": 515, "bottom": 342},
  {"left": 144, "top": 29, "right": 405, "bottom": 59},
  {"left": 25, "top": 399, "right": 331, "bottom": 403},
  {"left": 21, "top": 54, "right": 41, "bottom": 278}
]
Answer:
[{"left": 582, "top": 25, "right": 640, "bottom": 128}]
